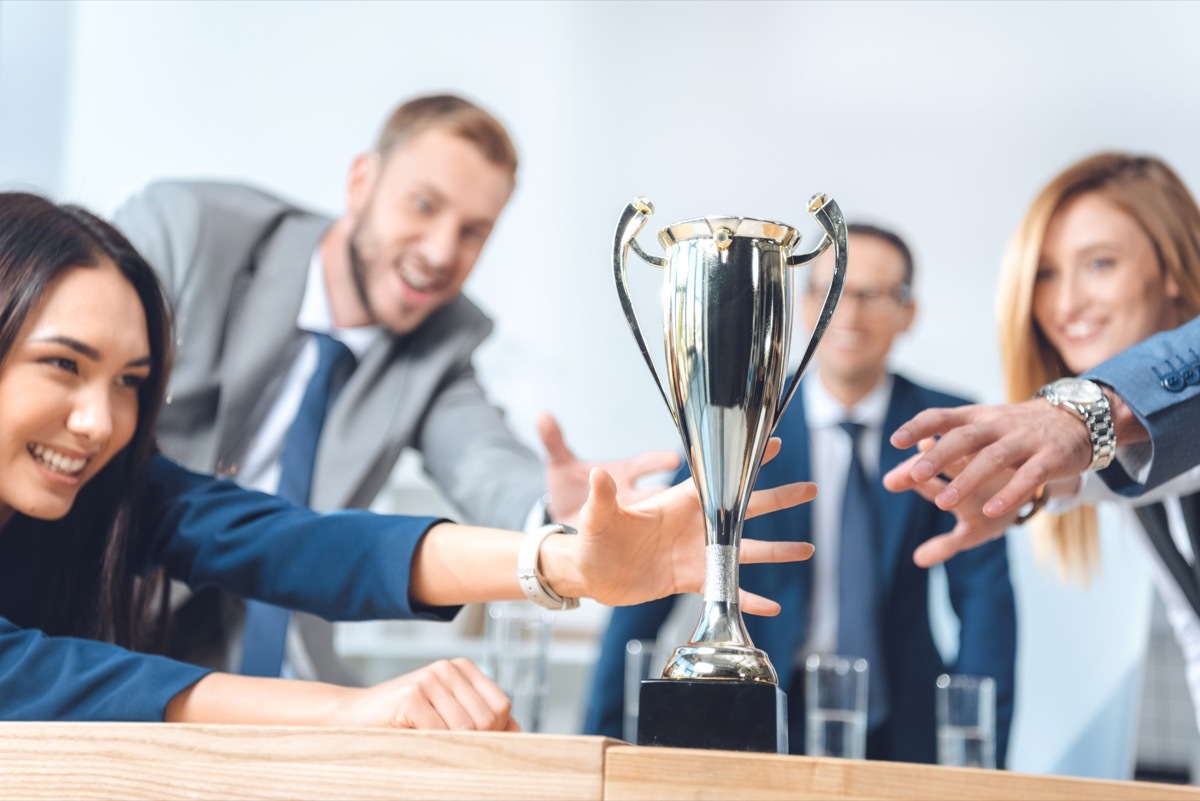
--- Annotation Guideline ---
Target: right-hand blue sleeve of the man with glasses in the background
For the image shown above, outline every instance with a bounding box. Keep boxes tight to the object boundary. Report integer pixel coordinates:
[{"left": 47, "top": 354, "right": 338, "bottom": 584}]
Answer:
[{"left": 946, "top": 527, "right": 1016, "bottom": 767}]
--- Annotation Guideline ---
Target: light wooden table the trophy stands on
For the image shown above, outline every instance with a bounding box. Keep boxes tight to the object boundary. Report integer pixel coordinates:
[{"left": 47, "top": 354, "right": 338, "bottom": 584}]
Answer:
[{"left": 0, "top": 723, "right": 1200, "bottom": 801}]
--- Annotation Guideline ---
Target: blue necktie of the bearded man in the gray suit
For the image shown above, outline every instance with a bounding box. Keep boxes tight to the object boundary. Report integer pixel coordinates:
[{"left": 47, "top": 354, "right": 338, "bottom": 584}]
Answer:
[{"left": 240, "top": 333, "right": 354, "bottom": 676}]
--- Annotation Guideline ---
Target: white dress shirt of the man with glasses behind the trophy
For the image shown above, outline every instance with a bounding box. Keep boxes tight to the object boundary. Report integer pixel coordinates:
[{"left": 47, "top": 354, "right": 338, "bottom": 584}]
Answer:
[{"left": 797, "top": 374, "right": 893, "bottom": 663}]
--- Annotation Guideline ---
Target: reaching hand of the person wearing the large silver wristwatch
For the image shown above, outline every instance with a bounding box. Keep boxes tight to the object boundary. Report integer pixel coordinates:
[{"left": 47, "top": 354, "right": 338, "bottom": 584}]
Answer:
[{"left": 883, "top": 398, "right": 1092, "bottom": 519}]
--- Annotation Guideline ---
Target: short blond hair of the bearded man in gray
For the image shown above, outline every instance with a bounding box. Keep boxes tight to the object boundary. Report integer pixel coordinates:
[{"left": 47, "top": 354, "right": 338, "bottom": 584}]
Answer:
[{"left": 374, "top": 95, "right": 517, "bottom": 180}]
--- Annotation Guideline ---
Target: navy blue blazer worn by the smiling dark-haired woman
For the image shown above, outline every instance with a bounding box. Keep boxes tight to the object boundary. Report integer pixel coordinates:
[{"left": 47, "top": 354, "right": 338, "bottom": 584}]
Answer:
[{"left": 0, "top": 457, "right": 458, "bottom": 721}]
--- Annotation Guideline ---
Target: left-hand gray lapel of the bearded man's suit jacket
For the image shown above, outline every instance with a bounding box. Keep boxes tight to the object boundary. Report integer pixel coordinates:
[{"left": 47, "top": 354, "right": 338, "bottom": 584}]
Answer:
[{"left": 216, "top": 216, "right": 329, "bottom": 472}]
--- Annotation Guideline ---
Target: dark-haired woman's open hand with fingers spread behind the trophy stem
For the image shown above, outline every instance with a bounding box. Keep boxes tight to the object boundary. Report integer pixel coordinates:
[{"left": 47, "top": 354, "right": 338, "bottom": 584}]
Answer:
[{"left": 561, "top": 439, "right": 816, "bottom": 615}]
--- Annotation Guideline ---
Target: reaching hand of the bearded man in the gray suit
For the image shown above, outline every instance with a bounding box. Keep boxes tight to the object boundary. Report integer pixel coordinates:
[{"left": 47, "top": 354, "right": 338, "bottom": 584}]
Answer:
[{"left": 538, "top": 412, "right": 679, "bottom": 528}]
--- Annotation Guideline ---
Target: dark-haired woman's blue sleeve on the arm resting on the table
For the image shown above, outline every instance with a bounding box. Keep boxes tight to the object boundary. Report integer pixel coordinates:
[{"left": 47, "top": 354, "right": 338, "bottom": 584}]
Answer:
[{"left": 0, "top": 618, "right": 210, "bottom": 722}]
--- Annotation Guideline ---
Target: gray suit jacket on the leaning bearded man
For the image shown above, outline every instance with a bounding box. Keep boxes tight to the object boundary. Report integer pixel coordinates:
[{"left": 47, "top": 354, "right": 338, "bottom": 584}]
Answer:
[{"left": 114, "top": 181, "right": 544, "bottom": 681}]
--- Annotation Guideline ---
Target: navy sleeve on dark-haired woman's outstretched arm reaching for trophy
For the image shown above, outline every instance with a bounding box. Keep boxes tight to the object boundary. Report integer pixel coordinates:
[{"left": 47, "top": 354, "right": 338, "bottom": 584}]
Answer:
[{"left": 143, "top": 457, "right": 458, "bottom": 620}]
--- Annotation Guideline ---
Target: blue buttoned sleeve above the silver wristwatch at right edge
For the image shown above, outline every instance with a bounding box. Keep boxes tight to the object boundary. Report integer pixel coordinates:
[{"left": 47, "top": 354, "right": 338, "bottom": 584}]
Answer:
[{"left": 1084, "top": 318, "right": 1200, "bottom": 496}]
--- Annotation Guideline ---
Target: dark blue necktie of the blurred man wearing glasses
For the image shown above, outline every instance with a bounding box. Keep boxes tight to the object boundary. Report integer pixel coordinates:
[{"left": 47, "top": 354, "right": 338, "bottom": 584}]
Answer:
[{"left": 838, "top": 422, "right": 888, "bottom": 728}]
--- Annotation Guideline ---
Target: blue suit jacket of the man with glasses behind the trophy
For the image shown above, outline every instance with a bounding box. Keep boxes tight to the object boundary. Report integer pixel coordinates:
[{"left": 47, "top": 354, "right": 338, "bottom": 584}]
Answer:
[{"left": 584, "top": 375, "right": 1016, "bottom": 765}]
